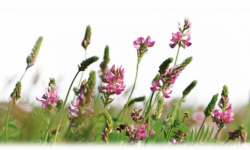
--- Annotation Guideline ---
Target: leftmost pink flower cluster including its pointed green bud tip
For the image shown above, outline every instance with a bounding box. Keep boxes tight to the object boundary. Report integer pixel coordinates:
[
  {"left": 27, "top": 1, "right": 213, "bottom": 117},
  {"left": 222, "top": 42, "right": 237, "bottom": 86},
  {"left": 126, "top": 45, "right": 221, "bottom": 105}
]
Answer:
[{"left": 36, "top": 78, "right": 61, "bottom": 111}]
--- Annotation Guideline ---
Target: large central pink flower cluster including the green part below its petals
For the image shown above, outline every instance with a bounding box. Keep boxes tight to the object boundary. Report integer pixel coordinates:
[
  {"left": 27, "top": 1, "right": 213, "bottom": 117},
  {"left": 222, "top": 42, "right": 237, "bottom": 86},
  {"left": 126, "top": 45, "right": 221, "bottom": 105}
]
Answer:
[{"left": 99, "top": 65, "right": 126, "bottom": 105}]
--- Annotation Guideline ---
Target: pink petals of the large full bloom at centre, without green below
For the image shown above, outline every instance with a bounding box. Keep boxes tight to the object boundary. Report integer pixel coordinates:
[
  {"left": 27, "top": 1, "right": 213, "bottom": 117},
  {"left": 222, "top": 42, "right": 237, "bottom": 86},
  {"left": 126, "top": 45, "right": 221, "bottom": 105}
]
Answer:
[{"left": 101, "top": 65, "right": 126, "bottom": 95}]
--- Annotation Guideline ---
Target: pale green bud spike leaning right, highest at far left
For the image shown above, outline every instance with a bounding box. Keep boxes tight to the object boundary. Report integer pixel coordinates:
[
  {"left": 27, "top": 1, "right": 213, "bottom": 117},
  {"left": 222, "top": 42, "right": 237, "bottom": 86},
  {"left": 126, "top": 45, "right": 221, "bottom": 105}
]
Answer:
[{"left": 26, "top": 37, "right": 43, "bottom": 69}]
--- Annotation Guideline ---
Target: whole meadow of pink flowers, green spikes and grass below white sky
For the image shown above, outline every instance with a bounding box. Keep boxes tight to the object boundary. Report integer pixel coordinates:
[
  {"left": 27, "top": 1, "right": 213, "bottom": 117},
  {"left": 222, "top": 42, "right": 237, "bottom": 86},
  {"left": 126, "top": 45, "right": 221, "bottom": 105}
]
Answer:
[{"left": 0, "top": 18, "right": 250, "bottom": 149}]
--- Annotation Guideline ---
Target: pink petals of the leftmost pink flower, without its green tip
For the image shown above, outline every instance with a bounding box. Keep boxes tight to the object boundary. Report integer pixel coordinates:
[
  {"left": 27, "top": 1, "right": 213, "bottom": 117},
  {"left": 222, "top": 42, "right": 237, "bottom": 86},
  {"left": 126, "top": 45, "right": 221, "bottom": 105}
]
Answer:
[{"left": 36, "top": 86, "right": 60, "bottom": 108}]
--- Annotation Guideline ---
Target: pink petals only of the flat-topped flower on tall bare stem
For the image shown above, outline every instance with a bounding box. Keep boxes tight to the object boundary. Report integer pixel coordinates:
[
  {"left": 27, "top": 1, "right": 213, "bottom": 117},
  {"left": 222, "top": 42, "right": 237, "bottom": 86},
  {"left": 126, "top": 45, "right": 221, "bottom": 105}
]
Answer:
[{"left": 133, "top": 36, "right": 155, "bottom": 49}]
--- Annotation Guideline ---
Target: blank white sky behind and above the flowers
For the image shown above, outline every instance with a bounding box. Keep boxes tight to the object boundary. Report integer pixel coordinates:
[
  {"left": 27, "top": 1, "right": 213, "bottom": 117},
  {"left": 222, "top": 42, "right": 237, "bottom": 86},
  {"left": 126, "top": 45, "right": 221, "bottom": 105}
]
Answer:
[{"left": 0, "top": 0, "right": 250, "bottom": 106}]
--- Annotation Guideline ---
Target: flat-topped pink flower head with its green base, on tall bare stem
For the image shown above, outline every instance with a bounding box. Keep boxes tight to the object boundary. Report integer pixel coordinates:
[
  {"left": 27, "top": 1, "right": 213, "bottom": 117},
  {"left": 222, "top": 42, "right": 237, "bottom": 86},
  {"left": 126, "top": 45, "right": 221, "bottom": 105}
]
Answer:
[{"left": 133, "top": 36, "right": 155, "bottom": 59}]
